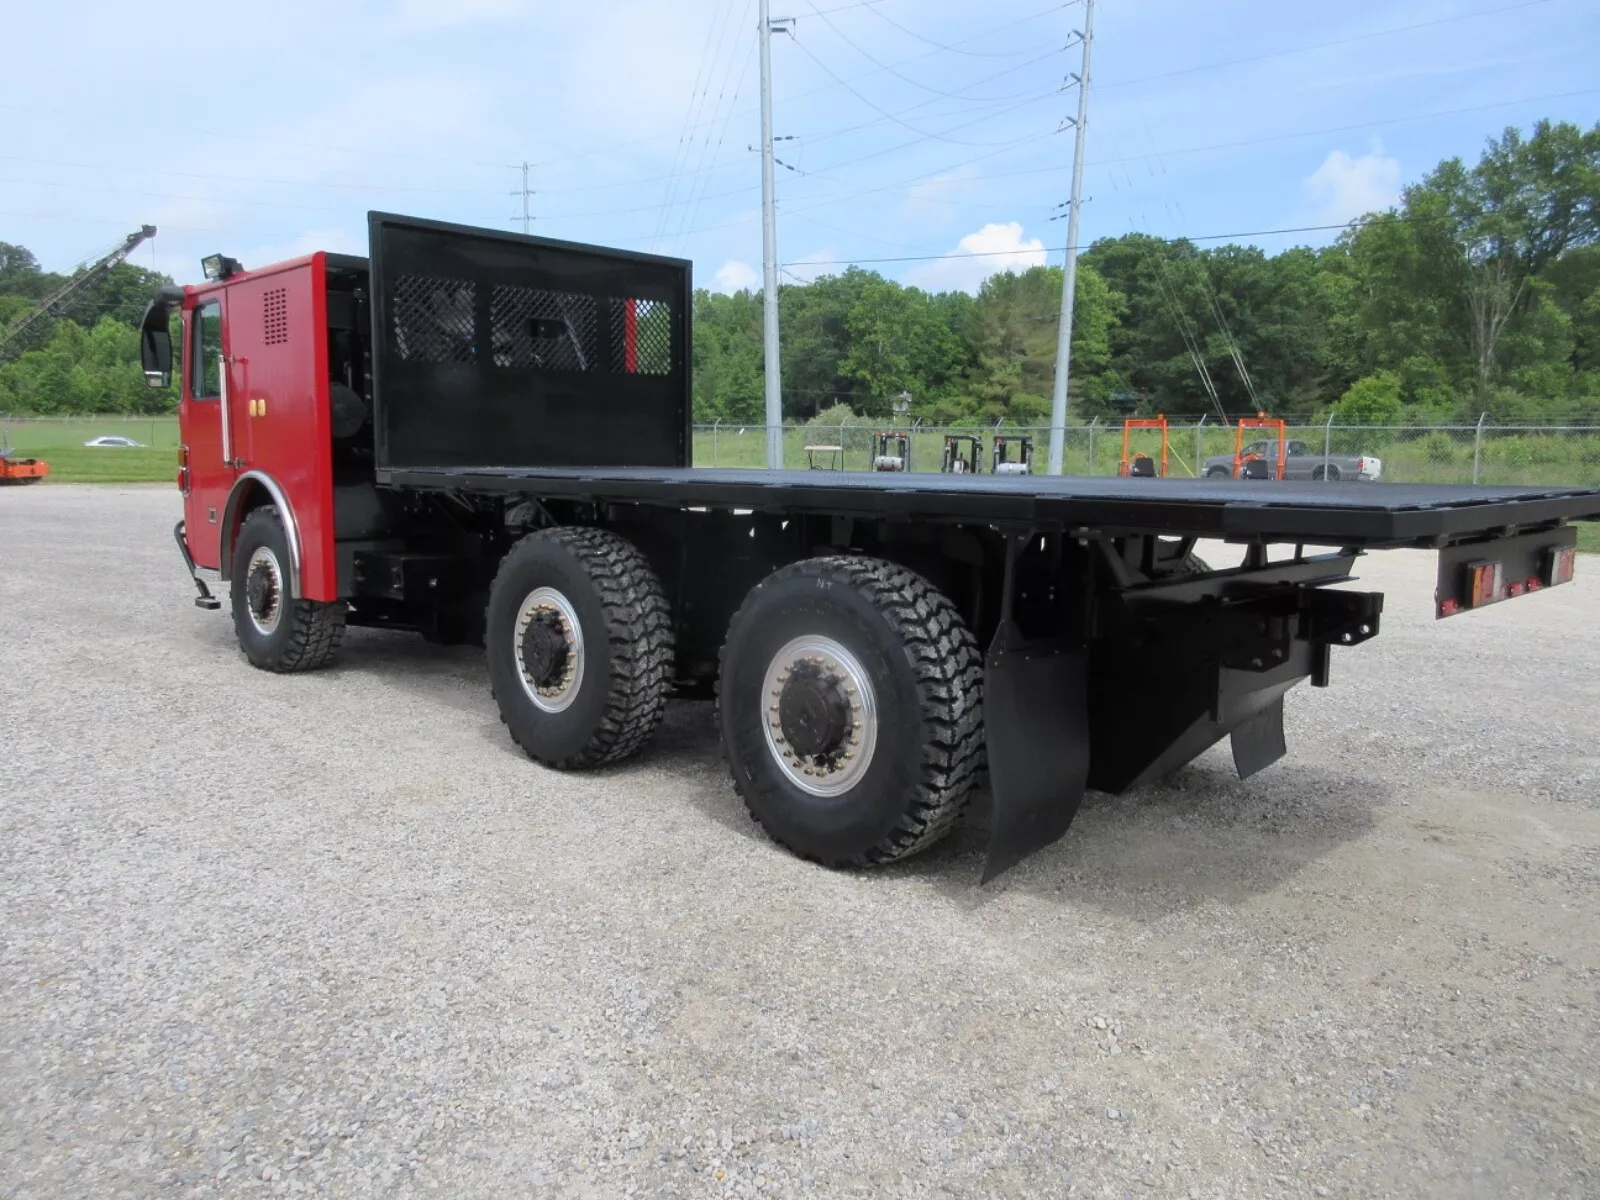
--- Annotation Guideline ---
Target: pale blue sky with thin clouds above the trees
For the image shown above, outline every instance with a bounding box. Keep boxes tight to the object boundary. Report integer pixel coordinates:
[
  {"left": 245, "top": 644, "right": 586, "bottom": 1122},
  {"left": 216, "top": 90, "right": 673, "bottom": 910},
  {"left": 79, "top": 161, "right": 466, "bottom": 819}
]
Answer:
[{"left": 0, "top": 0, "right": 1600, "bottom": 290}]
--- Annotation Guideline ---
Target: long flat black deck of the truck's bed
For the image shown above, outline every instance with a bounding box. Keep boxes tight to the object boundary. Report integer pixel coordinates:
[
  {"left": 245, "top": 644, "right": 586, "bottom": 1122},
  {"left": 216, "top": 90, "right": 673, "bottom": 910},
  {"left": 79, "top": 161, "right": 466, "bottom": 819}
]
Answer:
[{"left": 378, "top": 467, "right": 1600, "bottom": 547}]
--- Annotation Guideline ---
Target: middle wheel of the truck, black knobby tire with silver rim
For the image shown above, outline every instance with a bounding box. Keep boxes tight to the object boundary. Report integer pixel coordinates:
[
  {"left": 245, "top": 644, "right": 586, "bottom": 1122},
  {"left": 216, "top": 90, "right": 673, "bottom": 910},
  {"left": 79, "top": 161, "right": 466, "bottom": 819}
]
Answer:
[{"left": 485, "top": 526, "right": 674, "bottom": 770}]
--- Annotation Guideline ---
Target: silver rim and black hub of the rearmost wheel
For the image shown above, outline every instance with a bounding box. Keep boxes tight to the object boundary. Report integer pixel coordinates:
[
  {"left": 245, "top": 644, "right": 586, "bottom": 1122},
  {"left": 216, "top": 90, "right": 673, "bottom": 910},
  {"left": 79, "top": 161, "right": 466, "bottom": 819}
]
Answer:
[{"left": 762, "top": 634, "right": 878, "bottom": 797}]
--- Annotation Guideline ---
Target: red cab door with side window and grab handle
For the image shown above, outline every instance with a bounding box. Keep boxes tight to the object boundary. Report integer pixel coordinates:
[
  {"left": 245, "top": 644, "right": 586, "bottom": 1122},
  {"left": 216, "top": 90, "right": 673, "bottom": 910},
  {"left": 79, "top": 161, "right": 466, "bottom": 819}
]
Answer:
[{"left": 179, "top": 293, "right": 238, "bottom": 570}]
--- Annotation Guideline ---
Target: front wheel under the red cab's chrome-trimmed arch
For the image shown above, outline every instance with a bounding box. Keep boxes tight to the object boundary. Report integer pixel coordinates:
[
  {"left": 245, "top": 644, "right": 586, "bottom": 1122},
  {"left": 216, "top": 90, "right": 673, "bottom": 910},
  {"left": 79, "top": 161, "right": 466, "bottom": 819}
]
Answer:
[{"left": 229, "top": 504, "right": 344, "bottom": 674}]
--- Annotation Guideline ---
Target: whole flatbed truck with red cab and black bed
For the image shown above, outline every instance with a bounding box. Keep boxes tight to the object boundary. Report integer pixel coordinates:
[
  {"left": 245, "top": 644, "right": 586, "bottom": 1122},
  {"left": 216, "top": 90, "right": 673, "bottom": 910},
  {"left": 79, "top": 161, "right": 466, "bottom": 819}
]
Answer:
[{"left": 141, "top": 213, "right": 1600, "bottom": 878}]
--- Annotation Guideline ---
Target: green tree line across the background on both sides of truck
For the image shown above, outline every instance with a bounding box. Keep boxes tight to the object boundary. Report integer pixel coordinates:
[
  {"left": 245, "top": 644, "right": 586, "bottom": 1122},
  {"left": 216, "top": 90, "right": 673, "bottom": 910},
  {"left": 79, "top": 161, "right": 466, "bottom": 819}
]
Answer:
[{"left": 0, "top": 122, "right": 1600, "bottom": 424}]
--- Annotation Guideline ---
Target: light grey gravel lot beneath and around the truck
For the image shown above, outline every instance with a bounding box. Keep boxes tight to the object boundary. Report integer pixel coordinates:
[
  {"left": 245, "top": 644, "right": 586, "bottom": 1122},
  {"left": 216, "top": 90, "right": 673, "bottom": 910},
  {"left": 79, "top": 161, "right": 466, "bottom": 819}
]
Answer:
[{"left": 0, "top": 486, "right": 1600, "bottom": 1197}]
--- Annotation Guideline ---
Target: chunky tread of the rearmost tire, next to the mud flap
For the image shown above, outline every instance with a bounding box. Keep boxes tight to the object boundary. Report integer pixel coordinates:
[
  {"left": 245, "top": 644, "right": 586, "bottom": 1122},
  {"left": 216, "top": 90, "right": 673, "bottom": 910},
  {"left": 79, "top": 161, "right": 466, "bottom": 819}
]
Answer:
[{"left": 717, "top": 555, "right": 986, "bottom": 867}]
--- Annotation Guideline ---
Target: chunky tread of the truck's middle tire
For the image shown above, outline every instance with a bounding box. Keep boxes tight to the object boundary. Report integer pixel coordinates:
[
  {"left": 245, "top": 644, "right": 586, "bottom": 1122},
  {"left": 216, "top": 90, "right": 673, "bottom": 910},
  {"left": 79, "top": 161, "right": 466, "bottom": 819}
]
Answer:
[{"left": 490, "top": 525, "right": 675, "bottom": 771}]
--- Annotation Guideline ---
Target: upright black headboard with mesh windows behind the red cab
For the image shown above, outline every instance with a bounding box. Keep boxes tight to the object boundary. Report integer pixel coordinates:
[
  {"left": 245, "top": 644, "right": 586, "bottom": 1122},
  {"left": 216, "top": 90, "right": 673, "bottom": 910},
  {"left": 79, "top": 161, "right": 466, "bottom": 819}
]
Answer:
[{"left": 368, "top": 213, "right": 693, "bottom": 469}]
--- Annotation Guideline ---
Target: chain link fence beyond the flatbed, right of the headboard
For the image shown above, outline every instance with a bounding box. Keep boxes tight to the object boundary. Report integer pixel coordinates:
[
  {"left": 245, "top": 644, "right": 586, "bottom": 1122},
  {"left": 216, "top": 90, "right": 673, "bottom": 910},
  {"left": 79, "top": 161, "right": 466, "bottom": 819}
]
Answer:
[{"left": 694, "top": 414, "right": 1600, "bottom": 486}]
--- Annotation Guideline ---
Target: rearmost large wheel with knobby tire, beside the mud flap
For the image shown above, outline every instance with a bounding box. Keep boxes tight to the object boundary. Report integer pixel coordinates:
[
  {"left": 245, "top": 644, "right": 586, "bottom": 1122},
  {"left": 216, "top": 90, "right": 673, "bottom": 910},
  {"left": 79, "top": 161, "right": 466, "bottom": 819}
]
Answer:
[{"left": 717, "top": 557, "right": 984, "bottom": 867}]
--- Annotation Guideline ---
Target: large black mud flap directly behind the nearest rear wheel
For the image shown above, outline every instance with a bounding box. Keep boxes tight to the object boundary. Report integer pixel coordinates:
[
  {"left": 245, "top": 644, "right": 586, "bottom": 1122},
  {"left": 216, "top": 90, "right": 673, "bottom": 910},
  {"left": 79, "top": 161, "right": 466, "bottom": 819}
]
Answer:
[{"left": 982, "top": 621, "right": 1090, "bottom": 883}]
